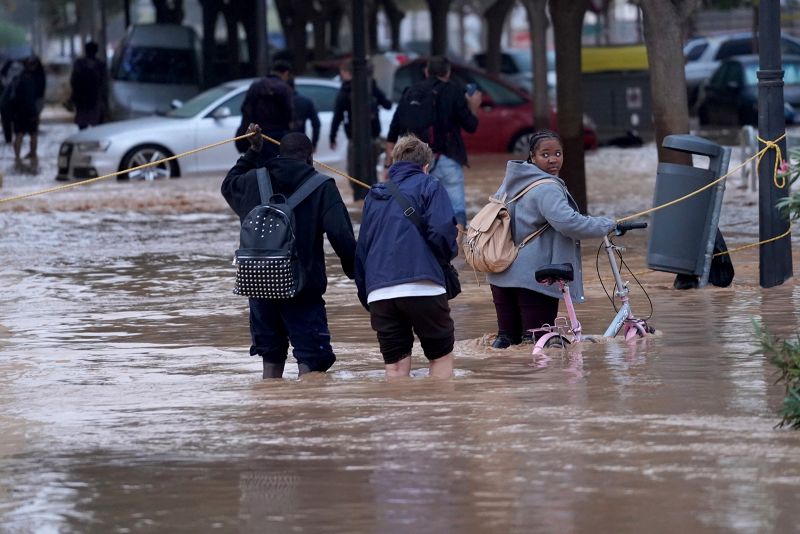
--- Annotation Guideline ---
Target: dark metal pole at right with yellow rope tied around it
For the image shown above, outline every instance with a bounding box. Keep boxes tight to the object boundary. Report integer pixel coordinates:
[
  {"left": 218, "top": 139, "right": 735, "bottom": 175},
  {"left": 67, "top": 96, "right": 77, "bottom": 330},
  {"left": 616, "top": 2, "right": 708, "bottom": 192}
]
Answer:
[{"left": 758, "top": 0, "right": 792, "bottom": 287}]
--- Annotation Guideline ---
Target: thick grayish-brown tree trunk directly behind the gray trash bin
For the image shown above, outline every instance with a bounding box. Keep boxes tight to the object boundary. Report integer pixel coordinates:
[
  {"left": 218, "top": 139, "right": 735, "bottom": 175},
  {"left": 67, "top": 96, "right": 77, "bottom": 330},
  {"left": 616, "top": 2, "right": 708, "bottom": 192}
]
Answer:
[{"left": 639, "top": 0, "right": 700, "bottom": 165}]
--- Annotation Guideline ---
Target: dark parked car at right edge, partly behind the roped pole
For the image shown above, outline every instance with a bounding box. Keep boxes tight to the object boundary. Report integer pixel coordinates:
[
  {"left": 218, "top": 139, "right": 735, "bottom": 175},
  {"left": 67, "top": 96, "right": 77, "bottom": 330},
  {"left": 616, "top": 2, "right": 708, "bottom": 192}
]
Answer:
[{"left": 697, "top": 54, "right": 800, "bottom": 126}]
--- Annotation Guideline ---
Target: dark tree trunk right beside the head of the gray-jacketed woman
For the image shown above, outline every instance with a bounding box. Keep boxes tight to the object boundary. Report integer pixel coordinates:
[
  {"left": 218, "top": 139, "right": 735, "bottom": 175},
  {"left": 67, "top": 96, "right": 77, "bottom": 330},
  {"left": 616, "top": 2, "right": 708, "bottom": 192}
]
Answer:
[{"left": 550, "top": 0, "right": 588, "bottom": 213}]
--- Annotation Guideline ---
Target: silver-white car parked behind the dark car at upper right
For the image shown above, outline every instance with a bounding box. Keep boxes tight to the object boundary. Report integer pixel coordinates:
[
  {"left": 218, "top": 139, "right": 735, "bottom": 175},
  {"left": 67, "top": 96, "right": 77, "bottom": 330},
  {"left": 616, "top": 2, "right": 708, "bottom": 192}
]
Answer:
[{"left": 683, "top": 33, "right": 800, "bottom": 110}]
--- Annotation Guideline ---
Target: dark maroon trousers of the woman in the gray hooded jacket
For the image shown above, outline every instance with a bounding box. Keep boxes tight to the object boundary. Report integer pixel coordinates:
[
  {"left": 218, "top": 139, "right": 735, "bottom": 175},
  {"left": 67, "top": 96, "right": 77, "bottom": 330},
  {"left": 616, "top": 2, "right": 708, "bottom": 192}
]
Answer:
[{"left": 491, "top": 285, "right": 559, "bottom": 343}]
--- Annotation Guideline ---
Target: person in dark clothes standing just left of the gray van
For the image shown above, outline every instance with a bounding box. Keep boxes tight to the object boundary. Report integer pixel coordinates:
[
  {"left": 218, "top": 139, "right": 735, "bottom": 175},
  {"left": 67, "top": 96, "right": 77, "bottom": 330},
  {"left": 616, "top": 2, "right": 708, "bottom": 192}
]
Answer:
[{"left": 69, "top": 41, "right": 108, "bottom": 130}]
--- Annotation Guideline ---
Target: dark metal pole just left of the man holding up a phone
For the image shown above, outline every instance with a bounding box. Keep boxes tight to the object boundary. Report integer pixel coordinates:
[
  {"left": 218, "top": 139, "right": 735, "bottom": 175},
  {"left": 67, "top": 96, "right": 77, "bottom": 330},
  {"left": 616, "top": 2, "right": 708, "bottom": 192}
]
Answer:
[{"left": 350, "top": 0, "right": 374, "bottom": 191}]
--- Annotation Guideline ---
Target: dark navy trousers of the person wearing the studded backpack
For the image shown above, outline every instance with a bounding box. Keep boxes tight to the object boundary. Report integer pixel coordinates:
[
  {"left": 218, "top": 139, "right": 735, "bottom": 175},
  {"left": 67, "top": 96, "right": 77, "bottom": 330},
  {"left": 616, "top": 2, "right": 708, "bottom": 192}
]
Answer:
[{"left": 250, "top": 297, "right": 336, "bottom": 372}]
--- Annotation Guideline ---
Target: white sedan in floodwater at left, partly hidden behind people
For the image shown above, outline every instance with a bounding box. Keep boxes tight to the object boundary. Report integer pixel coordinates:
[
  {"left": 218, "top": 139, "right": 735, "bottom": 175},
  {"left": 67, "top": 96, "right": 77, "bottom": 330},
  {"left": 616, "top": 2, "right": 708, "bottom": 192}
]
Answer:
[{"left": 57, "top": 78, "right": 393, "bottom": 180}]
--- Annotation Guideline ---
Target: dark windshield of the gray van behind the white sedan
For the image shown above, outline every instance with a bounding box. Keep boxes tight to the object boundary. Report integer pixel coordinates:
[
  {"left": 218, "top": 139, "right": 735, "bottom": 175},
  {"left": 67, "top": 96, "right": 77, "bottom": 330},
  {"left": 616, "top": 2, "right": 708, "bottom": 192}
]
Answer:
[{"left": 111, "top": 46, "right": 198, "bottom": 85}]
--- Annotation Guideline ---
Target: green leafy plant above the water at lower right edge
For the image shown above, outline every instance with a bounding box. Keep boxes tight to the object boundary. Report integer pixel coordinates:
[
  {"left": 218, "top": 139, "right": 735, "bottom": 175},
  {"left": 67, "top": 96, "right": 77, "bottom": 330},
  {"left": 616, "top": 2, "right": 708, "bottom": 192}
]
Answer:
[{"left": 753, "top": 320, "right": 800, "bottom": 430}]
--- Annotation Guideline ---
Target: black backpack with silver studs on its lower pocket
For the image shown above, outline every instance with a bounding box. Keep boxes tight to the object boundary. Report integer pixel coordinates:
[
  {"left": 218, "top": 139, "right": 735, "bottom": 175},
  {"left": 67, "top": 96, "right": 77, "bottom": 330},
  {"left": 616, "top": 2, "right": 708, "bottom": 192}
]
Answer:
[{"left": 233, "top": 167, "right": 333, "bottom": 299}]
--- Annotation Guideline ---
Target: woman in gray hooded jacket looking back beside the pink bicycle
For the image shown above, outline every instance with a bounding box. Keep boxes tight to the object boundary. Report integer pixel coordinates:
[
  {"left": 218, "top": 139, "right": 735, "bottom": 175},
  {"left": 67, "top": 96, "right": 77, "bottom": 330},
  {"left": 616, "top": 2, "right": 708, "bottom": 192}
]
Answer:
[{"left": 488, "top": 130, "right": 616, "bottom": 349}]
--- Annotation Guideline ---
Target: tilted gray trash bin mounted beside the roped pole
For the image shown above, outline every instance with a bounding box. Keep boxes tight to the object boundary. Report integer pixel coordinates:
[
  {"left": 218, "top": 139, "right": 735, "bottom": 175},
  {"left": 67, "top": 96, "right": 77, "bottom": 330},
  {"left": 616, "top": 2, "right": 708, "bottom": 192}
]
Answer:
[{"left": 647, "top": 135, "right": 731, "bottom": 287}]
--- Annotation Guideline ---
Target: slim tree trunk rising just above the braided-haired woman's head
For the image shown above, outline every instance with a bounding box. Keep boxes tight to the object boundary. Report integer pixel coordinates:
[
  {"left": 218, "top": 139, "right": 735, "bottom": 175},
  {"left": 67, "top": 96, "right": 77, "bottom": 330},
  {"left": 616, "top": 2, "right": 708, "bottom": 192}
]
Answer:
[{"left": 523, "top": 0, "right": 550, "bottom": 134}]
